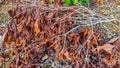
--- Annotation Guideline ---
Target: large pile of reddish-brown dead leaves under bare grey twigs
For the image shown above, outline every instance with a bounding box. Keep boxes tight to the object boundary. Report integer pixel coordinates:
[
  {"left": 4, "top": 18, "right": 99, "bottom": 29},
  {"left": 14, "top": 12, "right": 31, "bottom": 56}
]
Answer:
[{"left": 0, "top": 6, "right": 120, "bottom": 68}]
